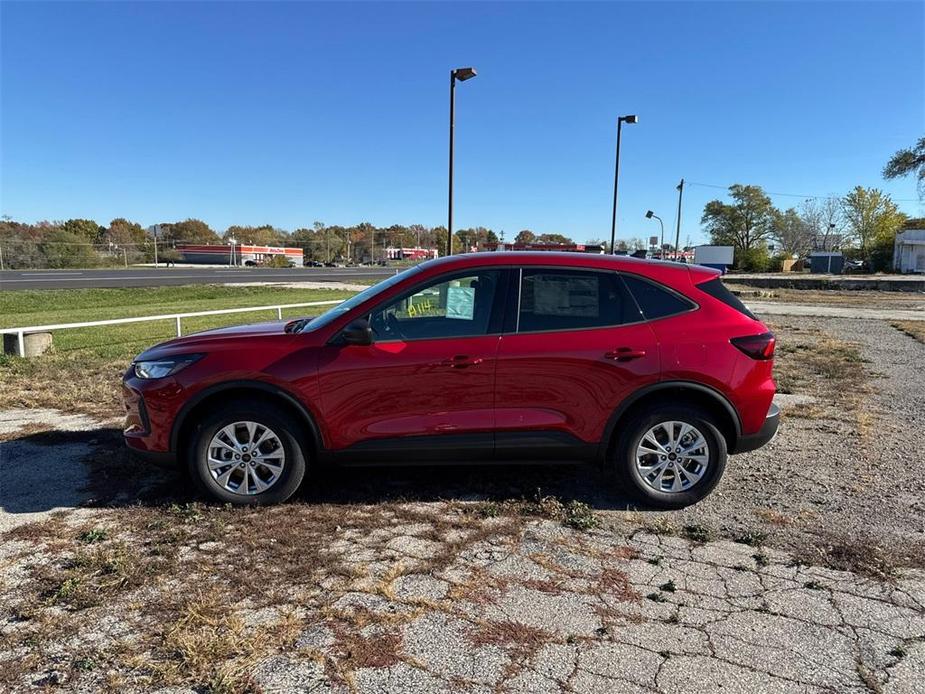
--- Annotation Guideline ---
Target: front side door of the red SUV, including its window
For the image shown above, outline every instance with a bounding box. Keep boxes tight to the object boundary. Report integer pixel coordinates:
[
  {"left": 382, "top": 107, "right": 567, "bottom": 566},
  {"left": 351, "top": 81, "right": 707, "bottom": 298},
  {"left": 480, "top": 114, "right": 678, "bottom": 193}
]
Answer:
[{"left": 319, "top": 269, "right": 506, "bottom": 461}]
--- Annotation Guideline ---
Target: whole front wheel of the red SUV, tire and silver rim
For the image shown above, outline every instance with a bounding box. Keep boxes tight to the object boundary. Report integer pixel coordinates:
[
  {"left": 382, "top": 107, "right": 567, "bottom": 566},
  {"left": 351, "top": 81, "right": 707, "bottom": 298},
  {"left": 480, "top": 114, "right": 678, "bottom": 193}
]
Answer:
[{"left": 190, "top": 404, "right": 305, "bottom": 505}]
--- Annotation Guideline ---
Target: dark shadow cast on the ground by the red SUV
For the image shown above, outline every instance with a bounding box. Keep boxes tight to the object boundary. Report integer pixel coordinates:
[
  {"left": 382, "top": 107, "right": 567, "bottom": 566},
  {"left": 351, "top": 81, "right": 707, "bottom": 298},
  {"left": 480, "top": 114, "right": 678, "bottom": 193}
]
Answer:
[{"left": 0, "top": 428, "right": 646, "bottom": 514}]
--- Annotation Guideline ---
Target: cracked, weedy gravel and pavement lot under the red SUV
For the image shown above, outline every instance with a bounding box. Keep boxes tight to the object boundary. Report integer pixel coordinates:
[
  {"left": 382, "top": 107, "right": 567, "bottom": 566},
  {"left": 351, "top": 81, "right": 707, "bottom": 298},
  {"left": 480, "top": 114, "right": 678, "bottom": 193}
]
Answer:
[{"left": 0, "top": 317, "right": 925, "bottom": 693}]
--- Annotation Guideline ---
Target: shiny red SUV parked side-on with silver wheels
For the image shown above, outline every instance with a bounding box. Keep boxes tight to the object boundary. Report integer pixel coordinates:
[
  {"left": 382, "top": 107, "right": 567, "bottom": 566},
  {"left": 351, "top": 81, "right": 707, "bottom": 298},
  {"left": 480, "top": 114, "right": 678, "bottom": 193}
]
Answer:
[{"left": 124, "top": 252, "right": 779, "bottom": 507}]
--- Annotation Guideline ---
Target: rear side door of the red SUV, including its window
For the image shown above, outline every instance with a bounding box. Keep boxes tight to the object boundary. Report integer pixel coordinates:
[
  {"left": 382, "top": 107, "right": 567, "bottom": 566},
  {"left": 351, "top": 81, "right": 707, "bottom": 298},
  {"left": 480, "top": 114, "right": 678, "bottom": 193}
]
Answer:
[{"left": 495, "top": 267, "right": 659, "bottom": 459}]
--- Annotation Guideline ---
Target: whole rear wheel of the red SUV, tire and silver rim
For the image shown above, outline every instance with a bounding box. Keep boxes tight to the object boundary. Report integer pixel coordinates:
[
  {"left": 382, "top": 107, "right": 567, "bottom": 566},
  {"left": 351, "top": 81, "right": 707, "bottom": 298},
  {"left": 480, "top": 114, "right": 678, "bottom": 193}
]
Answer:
[{"left": 614, "top": 406, "right": 727, "bottom": 508}]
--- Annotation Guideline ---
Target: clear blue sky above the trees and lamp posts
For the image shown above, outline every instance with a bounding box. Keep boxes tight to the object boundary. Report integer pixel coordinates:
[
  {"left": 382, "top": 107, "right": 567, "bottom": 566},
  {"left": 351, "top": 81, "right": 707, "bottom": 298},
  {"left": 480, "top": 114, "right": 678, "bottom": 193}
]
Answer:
[{"left": 0, "top": 2, "right": 925, "bottom": 242}]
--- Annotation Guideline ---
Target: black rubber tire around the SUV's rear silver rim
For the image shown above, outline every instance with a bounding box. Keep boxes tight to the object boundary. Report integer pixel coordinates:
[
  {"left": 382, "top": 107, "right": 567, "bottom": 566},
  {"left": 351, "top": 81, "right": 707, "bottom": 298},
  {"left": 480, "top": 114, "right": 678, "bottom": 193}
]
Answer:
[{"left": 613, "top": 405, "right": 727, "bottom": 509}]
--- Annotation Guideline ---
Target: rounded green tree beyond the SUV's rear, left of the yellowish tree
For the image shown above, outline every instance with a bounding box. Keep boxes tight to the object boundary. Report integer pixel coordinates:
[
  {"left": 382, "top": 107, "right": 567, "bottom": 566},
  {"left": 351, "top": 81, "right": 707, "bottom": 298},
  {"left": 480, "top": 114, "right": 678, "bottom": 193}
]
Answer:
[{"left": 700, "top": 184, "right": 775, "bottom": 267}]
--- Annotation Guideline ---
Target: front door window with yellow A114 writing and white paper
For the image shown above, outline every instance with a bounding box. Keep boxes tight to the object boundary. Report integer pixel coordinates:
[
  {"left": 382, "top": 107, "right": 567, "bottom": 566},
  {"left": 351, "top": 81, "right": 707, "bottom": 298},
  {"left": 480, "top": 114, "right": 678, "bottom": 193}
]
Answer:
[{"left": 370, "top": 270, "right": 501, "bottom": 340}]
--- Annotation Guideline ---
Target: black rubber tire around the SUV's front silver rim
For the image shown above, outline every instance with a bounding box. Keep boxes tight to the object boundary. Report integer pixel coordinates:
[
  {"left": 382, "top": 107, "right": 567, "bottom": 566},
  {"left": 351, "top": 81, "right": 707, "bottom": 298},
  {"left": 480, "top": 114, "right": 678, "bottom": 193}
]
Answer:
[{"left": 189, "top": 403, "right": 308, "bottom": 506}]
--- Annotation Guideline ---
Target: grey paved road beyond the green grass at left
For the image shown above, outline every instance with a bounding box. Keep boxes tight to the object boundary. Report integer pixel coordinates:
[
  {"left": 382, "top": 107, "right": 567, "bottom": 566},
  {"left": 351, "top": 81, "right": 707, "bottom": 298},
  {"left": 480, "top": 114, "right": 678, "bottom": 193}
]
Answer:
[{"left": 0, "top": 267, "right": 395, "bottom": 290}]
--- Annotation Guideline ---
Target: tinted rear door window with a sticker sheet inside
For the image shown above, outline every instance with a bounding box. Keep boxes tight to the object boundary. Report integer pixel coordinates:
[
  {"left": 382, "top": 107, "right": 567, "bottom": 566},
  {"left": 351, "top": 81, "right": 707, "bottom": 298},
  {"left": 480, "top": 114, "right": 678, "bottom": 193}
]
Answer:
[{"left": 517, "top": 268, "right": 639, "bottom": 333}]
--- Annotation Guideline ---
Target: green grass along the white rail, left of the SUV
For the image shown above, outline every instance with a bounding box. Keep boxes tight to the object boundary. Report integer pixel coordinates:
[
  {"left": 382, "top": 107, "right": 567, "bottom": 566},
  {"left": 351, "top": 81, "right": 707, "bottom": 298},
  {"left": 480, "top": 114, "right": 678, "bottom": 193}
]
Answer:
[{"left": 0, "top": 285, "right": 353, "bottom": 358}]
